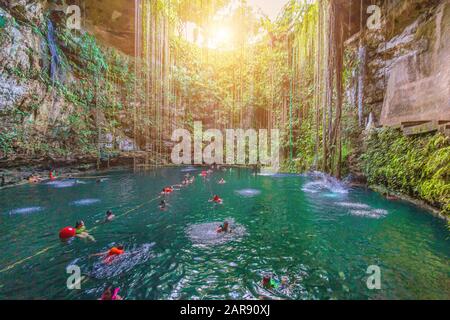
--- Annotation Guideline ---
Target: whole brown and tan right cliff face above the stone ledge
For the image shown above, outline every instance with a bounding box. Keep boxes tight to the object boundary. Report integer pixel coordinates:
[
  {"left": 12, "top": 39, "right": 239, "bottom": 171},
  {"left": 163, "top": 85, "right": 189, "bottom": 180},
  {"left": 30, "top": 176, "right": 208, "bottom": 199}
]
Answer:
[{"left": 347, "top": 0, "right": 450, "bottom": 126}]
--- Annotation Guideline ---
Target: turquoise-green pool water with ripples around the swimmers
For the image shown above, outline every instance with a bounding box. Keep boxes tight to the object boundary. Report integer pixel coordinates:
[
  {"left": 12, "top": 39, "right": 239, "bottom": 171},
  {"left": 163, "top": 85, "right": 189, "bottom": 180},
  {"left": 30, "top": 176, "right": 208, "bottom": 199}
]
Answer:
[{"left": 0, "top": 168, "right": 450, "bottom": 299}]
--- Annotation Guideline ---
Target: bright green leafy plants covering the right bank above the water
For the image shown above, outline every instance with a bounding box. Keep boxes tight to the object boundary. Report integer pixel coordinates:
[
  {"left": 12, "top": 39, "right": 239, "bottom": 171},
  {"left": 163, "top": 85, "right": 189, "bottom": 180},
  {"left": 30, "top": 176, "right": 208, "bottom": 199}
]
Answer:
[{"left": 362, "top": 129, "right": 450, "bottom": 215}]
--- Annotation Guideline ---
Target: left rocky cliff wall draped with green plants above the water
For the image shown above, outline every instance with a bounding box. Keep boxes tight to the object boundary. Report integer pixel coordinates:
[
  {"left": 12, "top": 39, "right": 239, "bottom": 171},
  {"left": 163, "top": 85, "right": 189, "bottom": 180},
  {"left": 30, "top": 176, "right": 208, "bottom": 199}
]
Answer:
[{"left": 0, "top": 0, "right": 139, "bottom": 163}]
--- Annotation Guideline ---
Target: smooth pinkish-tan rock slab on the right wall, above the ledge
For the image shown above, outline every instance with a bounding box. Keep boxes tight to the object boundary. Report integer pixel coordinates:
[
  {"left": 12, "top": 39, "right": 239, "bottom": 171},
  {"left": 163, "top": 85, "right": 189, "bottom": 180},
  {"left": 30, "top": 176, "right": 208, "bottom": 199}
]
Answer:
[{"left": 381, "top": 2, "right": 450, "bottom": 125}]
